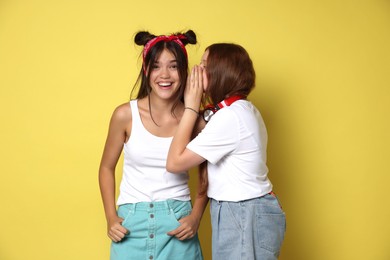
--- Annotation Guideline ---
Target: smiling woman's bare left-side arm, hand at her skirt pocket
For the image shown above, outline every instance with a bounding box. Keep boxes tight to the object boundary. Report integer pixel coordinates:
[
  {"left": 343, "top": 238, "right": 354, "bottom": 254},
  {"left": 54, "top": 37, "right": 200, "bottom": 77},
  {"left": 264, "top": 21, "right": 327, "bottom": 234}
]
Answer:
[{"left": 99, "top": 104, "right": 131, "bottom": 242}]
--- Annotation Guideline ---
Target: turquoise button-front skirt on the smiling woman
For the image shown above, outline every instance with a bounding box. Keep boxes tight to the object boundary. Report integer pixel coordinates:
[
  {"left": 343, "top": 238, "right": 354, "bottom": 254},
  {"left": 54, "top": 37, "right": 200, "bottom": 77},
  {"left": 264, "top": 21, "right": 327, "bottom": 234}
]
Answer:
[{"left": 110, "top": 200, "right": 203, "bottom": 260}]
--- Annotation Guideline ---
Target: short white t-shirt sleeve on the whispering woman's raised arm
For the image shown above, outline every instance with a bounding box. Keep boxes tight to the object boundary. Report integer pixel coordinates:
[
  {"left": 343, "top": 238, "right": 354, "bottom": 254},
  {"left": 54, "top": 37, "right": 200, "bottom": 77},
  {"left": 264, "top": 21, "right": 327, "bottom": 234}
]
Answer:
[{"left": 187, "top": 108, "right": 239, "bottom": 164}]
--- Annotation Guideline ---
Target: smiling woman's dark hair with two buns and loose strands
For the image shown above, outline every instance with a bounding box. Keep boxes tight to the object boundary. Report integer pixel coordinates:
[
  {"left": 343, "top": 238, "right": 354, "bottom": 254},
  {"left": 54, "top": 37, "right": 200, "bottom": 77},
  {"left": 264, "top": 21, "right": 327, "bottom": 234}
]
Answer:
[{"left": 131, "top": 30, "right": 197, "bottom": 121}]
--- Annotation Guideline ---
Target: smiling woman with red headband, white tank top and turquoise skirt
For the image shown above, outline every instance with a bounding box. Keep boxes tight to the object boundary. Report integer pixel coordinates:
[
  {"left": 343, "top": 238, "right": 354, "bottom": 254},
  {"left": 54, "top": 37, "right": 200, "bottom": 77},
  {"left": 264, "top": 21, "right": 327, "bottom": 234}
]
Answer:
[{"left": 99, "top": 31, "right": 208, "bottom": 260}]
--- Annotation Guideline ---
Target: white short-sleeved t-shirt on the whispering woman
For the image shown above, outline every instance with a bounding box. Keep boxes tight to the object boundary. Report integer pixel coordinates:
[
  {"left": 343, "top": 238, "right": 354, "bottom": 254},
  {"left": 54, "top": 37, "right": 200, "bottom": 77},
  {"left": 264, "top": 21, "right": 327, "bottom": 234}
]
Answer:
[{"left": 187, "top": 100, "right": 272, "bottom": 201}]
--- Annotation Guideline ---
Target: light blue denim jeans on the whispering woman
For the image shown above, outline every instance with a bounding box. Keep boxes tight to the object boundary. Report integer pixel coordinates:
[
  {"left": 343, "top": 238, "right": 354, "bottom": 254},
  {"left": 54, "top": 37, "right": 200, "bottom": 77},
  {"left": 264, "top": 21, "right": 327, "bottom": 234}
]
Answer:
[{"left": 210, "top": 194, "right": 286, "bottom": 260}]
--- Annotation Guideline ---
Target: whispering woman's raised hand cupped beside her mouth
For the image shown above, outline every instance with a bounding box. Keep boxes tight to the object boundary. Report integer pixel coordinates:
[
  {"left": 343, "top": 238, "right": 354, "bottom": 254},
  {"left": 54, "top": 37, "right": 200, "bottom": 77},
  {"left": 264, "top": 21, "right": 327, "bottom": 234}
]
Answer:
[{"left": 184, "top": 65, "right": 203, "bottom": 111}]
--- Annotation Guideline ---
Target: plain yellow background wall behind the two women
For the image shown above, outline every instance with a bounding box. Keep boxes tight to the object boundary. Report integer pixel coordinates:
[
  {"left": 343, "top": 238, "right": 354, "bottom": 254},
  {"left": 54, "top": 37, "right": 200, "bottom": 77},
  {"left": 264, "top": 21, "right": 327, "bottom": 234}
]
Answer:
[{"left": 0, "top": 0, "right": 390, "bottom": 260}]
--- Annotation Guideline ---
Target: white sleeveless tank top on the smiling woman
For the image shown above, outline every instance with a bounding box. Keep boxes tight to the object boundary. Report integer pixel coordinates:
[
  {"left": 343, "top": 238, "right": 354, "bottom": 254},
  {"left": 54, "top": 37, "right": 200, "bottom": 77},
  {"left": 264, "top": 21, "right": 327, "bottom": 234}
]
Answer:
[{"left": 117, "top": 100, "right": 190, "bottom": 205}]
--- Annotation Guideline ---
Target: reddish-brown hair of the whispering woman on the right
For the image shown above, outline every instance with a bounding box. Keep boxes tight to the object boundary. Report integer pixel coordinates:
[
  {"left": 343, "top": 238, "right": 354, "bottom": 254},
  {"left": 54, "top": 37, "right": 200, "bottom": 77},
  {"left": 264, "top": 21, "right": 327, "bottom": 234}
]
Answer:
[{"left": 206, "top": 43, "right": 256, "bottom": 104}]
